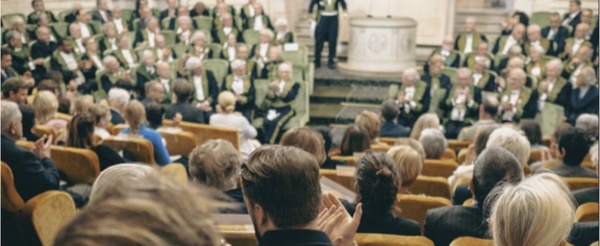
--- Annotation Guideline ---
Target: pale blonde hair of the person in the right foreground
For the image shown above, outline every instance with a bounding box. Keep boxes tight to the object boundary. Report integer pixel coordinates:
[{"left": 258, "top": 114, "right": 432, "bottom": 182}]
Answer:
[{"left": 490, "top": 173, "right": 575, "bottom": 246}]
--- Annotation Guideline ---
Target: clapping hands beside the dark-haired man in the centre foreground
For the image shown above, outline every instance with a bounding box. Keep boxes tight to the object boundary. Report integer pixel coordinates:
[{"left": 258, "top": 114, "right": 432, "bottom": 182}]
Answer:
[{"left": 317, "top": 194, "right": 362, "bottom": 246}]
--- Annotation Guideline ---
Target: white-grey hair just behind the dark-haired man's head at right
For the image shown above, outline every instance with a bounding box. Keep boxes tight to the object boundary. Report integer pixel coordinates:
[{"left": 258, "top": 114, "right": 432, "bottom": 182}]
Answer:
[{"left": 486, "top": 127, "right": 531, "bottom": 167}]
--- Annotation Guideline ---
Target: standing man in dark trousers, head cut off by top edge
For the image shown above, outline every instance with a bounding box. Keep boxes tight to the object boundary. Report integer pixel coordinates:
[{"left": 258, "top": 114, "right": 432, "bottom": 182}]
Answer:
[{"left": 308, "top": 0, "right": 348, "bottom": 69}]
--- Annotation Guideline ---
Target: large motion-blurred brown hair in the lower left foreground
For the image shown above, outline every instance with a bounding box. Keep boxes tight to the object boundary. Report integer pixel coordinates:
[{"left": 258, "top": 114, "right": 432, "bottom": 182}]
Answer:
[{"left": 54, "top": 174, "right": 221, "bottom": 245}]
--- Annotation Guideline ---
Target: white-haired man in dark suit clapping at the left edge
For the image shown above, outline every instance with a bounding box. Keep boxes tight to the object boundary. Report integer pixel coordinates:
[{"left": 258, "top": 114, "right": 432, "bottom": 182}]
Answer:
[{"left": 0, "top": 101, "right": 60, "bottom": 201}]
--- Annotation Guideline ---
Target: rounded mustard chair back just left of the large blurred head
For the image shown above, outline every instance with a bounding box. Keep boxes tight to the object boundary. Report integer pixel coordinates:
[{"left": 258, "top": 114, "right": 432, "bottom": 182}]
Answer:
[{"left": 23, "top": 191, "right": 76, "bottom": 246}]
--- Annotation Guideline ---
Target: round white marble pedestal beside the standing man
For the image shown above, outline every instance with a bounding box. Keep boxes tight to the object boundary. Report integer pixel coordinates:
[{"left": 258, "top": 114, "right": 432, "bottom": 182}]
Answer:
[{"left": 339, "top": 17, "right": 417, "bottom": 76}]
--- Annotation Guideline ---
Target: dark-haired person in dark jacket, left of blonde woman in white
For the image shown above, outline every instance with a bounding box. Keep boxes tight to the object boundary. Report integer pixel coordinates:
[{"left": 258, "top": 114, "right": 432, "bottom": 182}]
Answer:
[{"left": 165, "top": 79, "right": 204, "bottom": 124}]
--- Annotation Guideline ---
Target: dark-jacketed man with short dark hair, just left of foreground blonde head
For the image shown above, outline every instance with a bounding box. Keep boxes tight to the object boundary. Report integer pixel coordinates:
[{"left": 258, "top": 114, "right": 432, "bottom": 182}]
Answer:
[{"left": 424, "top": 147, "right": 523, "bottom": 245}]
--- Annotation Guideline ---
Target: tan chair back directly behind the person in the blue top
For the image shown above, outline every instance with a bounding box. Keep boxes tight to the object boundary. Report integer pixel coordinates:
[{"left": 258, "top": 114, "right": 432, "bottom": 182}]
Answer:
[{"left": 103, "top": 135, "right": 156, "bottom": 165}]
